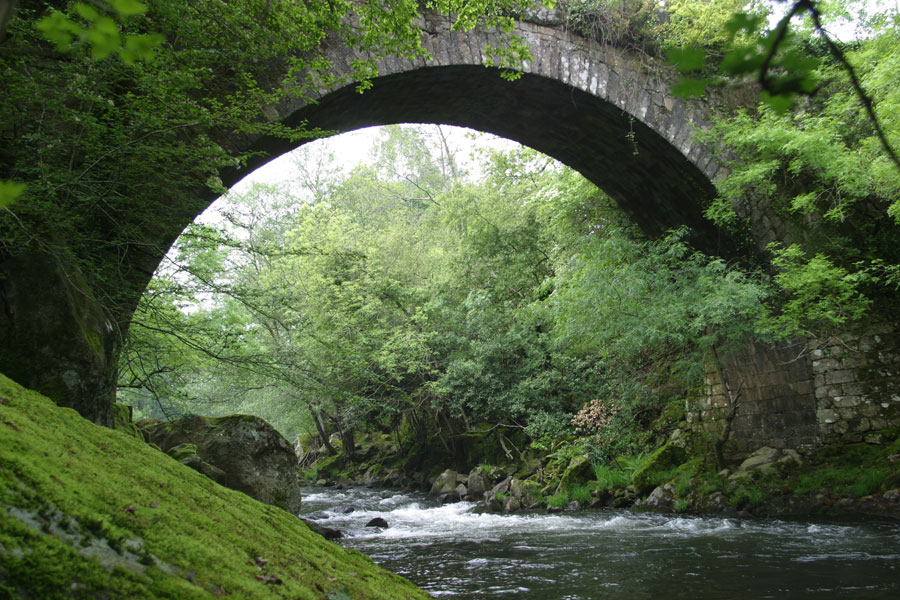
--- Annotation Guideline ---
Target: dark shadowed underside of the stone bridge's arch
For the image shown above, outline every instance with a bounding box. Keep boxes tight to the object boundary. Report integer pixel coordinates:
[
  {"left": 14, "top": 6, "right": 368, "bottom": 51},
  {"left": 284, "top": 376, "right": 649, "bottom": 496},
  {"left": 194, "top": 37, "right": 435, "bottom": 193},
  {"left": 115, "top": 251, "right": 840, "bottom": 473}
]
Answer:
[{"left": 226, "top": 65, "right": 730, "bottom": 254}]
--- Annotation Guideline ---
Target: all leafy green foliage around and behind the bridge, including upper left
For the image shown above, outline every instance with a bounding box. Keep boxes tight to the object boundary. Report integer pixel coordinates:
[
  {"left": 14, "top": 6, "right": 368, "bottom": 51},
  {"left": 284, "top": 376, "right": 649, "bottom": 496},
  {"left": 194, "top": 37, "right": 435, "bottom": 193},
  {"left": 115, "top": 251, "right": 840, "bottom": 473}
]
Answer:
[{"left": 0, "top": 0, "right": 900, "bottom": 504}]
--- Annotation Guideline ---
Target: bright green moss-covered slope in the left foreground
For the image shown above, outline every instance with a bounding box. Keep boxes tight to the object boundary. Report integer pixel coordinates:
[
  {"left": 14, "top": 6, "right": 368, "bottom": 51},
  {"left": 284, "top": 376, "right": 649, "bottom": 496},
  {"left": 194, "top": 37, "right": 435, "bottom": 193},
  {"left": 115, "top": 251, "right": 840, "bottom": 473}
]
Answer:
[{"left": 0, "top": 375, "right": 428, "bottom": 600}]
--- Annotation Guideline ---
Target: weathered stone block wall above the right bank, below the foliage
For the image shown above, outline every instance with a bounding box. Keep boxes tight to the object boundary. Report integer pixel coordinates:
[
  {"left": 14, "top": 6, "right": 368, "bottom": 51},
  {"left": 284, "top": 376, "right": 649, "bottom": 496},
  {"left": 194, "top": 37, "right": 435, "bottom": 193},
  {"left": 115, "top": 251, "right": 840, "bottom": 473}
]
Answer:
[{"left": 686, "top": 325, "right": 900, "bottom": 459}]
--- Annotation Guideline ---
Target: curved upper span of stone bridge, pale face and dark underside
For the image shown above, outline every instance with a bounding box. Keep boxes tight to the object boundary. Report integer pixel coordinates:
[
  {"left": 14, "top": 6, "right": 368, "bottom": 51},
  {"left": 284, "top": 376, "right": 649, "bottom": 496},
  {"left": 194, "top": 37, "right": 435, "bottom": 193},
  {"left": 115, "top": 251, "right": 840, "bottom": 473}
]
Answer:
[{"left": 223, "top": 17, "right": 732, "bottom": 248}]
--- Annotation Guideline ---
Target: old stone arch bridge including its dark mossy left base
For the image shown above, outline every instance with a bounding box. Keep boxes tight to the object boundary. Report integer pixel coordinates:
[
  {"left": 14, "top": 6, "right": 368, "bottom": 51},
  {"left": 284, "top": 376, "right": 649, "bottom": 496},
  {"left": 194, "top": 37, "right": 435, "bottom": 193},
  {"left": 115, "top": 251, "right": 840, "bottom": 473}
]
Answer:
[{"left": 0, "top": 8, "right": 828, "bottom": 454}]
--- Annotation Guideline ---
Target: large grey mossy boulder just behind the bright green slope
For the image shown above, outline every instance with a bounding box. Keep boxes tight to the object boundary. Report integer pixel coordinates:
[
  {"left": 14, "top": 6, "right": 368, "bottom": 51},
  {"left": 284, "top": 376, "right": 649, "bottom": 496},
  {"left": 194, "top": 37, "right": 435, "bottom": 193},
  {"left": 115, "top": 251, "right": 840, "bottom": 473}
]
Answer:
[{"left": 138, "top": 415, "right": 300, "bottom": 514}]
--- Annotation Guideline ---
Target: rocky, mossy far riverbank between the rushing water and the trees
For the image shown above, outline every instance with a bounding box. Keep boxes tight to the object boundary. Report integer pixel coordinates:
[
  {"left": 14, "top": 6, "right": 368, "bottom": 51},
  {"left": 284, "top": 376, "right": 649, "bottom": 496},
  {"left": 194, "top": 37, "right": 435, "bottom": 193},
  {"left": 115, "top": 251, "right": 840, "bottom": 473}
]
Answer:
[{"left": 302, "top": 424, "right": 900, "bottom": 516}]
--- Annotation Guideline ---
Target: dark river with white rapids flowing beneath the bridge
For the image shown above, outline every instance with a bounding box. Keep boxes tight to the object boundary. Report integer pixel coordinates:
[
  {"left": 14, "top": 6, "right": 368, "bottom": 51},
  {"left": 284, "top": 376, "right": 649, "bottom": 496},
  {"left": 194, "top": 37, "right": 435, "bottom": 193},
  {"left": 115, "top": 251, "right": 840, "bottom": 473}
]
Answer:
[{"left": 303, "top": 488, "right": 900, "bottom": 600}]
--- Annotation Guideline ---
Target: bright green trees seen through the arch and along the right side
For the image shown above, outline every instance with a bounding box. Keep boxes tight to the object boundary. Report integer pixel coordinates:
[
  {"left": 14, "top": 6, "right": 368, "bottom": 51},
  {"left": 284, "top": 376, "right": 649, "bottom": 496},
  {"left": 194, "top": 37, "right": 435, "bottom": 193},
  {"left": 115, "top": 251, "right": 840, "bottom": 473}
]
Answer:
[{"left": 109, "top": 3, "right": 900, "bottom": 486}]
